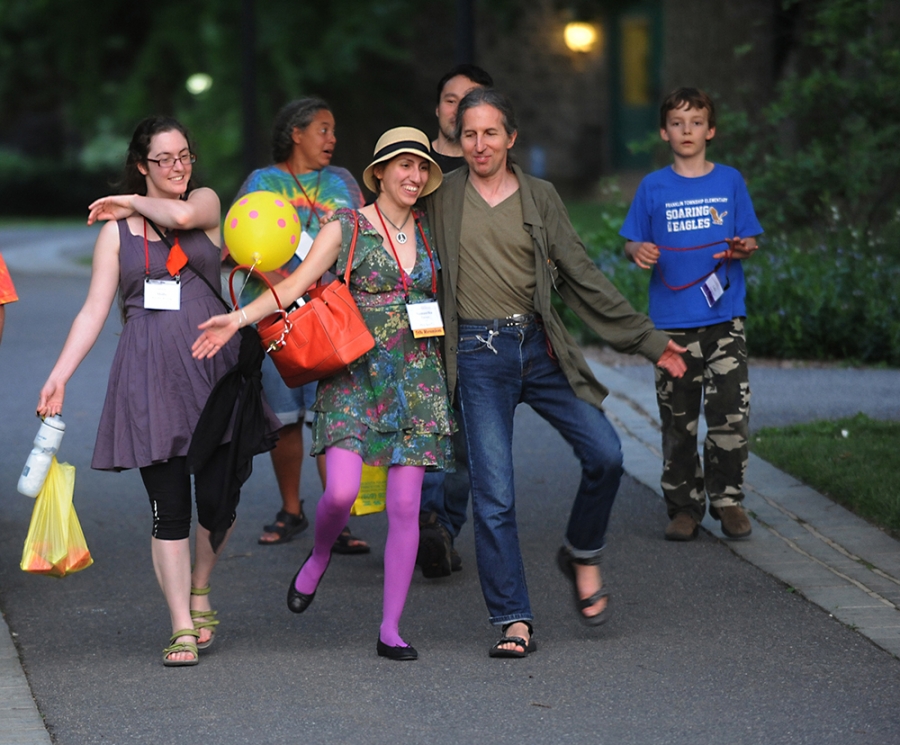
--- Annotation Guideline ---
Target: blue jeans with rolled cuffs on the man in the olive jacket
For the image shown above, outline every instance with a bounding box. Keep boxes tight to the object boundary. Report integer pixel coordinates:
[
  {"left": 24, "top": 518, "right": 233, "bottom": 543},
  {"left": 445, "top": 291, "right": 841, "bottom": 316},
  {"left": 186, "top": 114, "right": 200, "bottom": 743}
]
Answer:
[{"left": 457, "top": 320, "right": 622, "bottom": 626}]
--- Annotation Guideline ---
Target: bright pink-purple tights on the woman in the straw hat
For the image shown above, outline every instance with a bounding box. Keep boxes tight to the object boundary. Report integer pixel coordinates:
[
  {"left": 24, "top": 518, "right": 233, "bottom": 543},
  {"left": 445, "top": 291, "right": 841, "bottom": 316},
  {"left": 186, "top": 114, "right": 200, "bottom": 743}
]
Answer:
[{"left": 294, "top": 447, "right": 425, "bottom": 647}]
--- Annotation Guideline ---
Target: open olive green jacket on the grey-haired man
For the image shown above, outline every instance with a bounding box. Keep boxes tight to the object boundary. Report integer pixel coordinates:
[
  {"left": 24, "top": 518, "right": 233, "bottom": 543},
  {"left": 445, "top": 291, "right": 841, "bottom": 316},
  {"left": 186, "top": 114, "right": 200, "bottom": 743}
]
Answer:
[{"left": 425, "top": 166, "right": 669, "bottom": 407}]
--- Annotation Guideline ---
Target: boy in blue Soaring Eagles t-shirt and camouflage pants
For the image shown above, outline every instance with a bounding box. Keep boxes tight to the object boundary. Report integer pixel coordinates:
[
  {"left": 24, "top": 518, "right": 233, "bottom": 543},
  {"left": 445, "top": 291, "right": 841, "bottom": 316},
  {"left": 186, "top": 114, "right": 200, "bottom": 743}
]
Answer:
[{"left": 620, "top": 88, "right": 763, "bottom": 541}]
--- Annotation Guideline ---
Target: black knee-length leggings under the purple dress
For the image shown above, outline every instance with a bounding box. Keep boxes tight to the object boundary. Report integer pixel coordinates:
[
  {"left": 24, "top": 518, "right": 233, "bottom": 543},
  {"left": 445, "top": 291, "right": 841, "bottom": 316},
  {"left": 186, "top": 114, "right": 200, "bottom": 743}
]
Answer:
[{"left": 141, "top": 445, "right": 235, "bottom": 541}]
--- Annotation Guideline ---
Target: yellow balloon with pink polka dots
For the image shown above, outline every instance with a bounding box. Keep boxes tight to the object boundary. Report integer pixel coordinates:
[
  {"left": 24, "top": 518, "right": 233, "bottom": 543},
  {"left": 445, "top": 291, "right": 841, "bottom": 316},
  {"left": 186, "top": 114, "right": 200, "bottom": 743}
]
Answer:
[{"left": 223, "top": 191, "right": 300, "bottom": 272}]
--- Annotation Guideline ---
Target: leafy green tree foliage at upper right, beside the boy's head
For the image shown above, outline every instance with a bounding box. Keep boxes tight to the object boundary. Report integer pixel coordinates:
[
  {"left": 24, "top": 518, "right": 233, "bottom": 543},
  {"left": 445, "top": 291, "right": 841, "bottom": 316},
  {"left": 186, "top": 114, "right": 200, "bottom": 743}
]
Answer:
[{"left": 711, "top": 0, "right": 900, "bottom": 240}]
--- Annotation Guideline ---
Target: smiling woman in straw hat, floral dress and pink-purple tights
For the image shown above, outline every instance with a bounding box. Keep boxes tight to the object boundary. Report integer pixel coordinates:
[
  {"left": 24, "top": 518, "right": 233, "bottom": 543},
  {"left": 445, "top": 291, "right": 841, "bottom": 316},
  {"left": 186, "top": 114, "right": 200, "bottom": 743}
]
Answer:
[{"left": 193, "top": 127, "right": 452, "bottom": 660}]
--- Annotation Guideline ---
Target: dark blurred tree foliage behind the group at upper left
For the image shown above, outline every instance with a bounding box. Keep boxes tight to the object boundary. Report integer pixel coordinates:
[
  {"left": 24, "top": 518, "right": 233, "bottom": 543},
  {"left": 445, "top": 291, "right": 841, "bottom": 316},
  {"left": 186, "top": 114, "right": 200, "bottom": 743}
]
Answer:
[{"left": 0, "top": 0, "right": 428, "bottom": 206}]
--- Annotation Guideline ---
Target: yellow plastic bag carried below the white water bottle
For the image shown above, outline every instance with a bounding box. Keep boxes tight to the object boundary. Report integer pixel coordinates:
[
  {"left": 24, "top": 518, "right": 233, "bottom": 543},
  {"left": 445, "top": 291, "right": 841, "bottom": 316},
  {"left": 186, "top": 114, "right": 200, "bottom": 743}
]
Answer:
[{"left": 19, "top": 456, "right": 94, "bottom": 577}]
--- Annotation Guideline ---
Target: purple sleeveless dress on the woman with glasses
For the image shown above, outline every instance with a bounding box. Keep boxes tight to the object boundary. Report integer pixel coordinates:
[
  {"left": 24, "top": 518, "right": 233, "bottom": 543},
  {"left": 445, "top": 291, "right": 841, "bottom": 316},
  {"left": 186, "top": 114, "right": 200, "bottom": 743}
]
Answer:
[{"left": 91, "top": 220, "right": 240, "bottom": 471}]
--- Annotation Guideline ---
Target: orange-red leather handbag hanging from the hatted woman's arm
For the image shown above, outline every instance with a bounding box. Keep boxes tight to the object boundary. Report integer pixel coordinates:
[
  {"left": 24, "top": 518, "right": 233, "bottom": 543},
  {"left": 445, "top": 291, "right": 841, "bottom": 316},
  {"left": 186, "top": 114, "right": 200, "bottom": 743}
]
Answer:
[{"left": 228, "top": 217, "right": 375, "bottom": 388}]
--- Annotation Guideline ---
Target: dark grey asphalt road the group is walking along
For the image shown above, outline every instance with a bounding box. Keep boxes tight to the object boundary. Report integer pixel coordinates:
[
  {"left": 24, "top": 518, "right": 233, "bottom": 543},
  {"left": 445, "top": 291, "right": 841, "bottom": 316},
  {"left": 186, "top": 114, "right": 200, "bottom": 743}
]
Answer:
[{"left": 0, "top": 231, "right": 900, "bottom": 745}]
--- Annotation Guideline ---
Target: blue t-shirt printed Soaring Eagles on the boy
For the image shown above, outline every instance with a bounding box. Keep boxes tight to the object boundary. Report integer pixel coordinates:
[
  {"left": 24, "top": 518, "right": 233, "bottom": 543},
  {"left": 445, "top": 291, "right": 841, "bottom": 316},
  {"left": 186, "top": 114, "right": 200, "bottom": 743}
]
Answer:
[{"left": 619, "top": 164, "right": 763, "bottom": 329}]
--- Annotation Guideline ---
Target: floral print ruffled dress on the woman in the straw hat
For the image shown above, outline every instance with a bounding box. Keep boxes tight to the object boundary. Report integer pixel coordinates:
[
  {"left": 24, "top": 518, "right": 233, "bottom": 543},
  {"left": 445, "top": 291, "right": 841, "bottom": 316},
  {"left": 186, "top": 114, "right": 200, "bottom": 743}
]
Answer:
[{"left": 312, "top": 209, "right": 454, "bottom": 468}]
